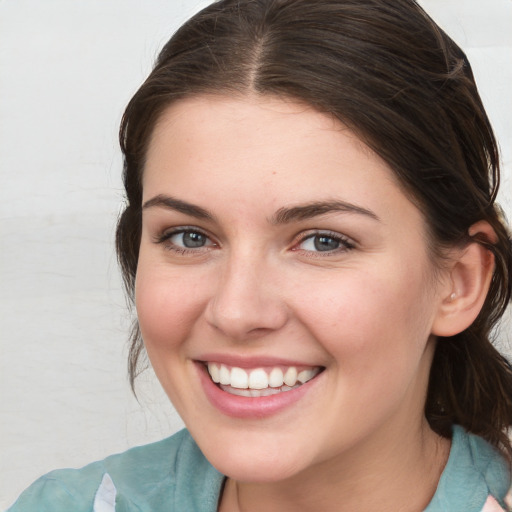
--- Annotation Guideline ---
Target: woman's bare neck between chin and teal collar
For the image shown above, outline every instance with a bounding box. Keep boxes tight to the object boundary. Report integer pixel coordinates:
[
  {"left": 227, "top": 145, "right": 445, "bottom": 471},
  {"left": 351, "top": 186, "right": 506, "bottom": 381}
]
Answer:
[{"left": 219, "top": 421, "right": 450, "bottom": 512}]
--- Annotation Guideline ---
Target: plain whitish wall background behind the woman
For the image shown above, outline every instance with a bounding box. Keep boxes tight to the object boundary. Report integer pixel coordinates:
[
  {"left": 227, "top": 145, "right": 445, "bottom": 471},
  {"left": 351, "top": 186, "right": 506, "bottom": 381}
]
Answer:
[{"left": 0, "top": 0, "right": 512, "bottom": 508}]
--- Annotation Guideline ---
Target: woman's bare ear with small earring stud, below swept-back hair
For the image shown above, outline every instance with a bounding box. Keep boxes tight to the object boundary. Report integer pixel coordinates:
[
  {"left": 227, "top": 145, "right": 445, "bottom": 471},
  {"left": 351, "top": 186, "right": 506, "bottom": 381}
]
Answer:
[{"left": 432, "top": 221, "right": 497, "bottom": 336}]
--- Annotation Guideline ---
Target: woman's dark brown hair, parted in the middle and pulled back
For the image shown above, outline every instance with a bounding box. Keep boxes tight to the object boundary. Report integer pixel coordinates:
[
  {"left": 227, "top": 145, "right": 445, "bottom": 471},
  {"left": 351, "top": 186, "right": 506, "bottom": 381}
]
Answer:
[{"left": 117, "top": 0, "right": 512, "bottom": 453}]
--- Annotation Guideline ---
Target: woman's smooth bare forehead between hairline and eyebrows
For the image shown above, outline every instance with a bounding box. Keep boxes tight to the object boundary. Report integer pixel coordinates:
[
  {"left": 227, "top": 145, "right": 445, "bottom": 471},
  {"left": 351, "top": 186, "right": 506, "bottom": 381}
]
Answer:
[{"left": 143, "top": 96, "right": 420, "bottom": 226}]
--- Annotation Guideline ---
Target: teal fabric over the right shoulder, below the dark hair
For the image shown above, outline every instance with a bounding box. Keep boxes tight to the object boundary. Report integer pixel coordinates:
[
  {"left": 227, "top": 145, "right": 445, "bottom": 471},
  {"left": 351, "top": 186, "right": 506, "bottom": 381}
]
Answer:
[{"left": 425, "top": 426, "right": 511, "bottom": 512}]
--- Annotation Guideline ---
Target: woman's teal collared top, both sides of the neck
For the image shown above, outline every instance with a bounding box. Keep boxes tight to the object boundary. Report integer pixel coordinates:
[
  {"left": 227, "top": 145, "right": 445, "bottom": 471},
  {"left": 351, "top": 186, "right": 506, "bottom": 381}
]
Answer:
[{"left": 8, "top": 426, "right": 510, "bottom": 512}]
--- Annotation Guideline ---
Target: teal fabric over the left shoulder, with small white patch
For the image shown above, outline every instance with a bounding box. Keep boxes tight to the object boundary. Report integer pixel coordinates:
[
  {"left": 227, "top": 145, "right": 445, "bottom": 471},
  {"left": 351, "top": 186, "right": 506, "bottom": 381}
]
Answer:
[{"left": 9, "top": 430, "right": 223, "bottom": 512}]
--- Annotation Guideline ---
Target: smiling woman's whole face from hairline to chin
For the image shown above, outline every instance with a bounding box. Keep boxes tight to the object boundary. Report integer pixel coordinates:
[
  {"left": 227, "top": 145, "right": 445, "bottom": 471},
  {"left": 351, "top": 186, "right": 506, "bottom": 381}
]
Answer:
[{"left": 136, "top": 96, "right": 443, "bottom": 481}]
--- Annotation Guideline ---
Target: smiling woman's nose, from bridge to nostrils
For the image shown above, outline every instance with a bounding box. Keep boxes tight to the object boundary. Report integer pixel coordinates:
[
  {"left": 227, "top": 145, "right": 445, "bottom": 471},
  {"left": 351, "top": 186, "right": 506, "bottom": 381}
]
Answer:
[{"left": 205, "top": 251, "right": 288, "bottom": 341}]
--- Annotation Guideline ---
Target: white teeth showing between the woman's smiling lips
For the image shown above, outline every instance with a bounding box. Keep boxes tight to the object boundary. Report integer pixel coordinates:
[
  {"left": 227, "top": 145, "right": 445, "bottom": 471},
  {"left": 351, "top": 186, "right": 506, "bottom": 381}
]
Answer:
[{"left": 206, "top": 362, "right": 324, "bottom": 398}]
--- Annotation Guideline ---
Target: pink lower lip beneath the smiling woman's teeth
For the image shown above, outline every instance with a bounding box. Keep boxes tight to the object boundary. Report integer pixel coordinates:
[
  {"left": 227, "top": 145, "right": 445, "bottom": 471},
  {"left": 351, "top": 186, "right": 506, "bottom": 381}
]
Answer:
[{"left": 196, "top": 363, "right": 321, "bottom": 418}]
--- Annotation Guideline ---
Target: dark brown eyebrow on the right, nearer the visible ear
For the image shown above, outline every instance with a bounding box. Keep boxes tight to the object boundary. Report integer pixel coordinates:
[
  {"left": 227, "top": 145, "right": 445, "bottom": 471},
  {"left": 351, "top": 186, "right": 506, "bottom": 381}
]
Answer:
[{"left": 270, "top": 200, "right": 380, "bottom": 224}]
